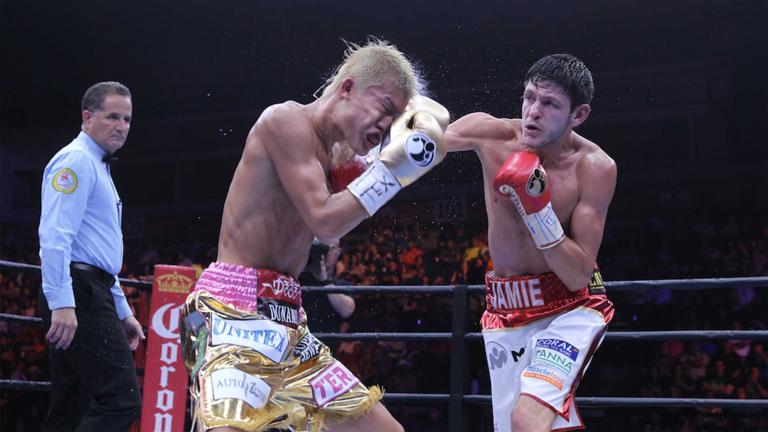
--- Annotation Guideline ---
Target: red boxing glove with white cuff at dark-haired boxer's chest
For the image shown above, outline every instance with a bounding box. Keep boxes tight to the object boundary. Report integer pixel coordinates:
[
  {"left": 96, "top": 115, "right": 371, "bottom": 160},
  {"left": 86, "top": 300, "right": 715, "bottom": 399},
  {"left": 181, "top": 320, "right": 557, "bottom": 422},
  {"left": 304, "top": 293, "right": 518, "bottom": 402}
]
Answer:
[{"left": 493, "top": 151, "right": 565, "bottom": 249}]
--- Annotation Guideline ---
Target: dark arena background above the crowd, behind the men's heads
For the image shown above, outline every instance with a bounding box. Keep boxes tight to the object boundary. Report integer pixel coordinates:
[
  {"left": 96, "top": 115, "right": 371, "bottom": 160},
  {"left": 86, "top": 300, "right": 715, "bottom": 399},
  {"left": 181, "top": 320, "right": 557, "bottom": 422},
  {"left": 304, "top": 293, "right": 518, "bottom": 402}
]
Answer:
[{"left": 0, "top": 1, "right": 768, "bottom": 239}]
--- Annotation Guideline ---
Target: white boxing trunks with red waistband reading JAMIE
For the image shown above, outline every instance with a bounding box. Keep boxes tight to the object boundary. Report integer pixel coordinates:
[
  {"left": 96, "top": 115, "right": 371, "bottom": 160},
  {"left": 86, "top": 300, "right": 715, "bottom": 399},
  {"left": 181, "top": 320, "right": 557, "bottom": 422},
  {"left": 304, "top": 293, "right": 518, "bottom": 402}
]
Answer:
[{"left": 481, "top": 271, "right": 613, "bottom": 432}]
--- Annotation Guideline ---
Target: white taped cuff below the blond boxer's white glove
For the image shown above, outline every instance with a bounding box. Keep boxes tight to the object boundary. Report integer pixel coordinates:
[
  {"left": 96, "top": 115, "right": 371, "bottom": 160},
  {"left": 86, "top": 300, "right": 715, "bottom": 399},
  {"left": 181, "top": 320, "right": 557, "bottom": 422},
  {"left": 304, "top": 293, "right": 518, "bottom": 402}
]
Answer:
[{"left": 347, "top": 159, "right": 403, "bottom": 216}]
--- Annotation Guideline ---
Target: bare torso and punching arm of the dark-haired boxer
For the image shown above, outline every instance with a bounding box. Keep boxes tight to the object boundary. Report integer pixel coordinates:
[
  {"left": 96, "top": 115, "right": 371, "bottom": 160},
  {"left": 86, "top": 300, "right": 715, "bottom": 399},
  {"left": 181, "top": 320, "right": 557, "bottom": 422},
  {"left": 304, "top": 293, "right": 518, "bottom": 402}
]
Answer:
[{"left": 446, "top": 113, "right": 615, "bottom": 276}]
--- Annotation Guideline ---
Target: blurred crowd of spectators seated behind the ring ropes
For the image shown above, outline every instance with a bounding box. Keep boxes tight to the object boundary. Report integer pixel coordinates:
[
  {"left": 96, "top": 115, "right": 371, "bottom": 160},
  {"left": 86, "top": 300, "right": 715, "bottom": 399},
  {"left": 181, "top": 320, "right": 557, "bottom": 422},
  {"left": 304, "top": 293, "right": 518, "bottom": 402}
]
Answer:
[{"left": 0, "top": 208, "right": 768, "bottom": 431}]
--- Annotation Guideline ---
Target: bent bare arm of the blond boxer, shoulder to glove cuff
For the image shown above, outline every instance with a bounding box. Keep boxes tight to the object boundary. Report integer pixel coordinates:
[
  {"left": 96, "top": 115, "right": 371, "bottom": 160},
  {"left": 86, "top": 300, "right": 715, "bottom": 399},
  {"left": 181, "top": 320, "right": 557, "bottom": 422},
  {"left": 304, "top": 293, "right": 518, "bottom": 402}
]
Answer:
[{"left": 260, "top": 104, "right": 368, "bottom": 243}]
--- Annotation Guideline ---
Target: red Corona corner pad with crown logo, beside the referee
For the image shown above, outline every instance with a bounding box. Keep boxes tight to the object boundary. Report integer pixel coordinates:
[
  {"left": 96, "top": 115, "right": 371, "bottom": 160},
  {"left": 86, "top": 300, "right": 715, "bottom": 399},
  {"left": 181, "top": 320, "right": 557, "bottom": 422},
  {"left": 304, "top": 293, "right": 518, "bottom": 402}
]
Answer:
[{"left": 141, "top": 265, "right": 196, "bottom": 432}]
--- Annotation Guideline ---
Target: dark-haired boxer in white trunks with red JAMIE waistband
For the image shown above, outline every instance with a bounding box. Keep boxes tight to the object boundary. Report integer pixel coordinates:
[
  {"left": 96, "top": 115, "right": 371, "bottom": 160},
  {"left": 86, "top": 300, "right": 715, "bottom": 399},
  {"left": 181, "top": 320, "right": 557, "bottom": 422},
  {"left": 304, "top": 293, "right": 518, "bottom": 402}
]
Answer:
[{"left": 445, "top": 54, "right": 616, "bottom": 432}]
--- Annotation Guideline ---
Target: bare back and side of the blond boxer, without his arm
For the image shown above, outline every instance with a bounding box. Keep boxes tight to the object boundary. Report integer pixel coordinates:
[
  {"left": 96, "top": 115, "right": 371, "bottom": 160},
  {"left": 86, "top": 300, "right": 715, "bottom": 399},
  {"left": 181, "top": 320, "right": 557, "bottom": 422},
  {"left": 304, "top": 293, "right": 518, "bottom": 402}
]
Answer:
[{"left": 217, "top": 102, "right": 318, "bottom": 275}]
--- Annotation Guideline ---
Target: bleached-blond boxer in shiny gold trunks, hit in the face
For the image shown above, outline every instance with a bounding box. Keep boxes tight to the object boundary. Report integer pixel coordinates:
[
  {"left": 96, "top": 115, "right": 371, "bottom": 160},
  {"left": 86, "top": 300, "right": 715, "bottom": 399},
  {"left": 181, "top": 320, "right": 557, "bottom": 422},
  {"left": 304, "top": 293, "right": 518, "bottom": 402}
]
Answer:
[{"left": 182, "top": 39, "right": 449, "bottom": 431}]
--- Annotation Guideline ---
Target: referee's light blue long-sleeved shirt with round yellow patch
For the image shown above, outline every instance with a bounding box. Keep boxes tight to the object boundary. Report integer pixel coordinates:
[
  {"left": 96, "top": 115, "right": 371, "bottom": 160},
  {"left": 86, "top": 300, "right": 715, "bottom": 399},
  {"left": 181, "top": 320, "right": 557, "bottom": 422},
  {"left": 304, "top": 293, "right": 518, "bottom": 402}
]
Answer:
[{"left": 38, "top": 132, "right": 133, "bottom": 320}]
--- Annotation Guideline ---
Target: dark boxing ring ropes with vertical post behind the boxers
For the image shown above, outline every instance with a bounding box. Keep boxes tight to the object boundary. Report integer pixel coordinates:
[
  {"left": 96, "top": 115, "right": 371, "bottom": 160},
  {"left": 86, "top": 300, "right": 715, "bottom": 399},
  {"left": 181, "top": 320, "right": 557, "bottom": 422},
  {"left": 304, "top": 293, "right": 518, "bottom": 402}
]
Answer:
[{"left": 0, "top": 260, "right": 768, "bottom": 430}]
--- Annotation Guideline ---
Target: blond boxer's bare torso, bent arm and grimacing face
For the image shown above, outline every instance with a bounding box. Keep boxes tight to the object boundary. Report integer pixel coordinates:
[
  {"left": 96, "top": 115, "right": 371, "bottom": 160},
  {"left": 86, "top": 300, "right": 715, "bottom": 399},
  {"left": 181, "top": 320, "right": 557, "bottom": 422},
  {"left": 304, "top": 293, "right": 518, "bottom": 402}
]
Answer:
[{"left": 217, "top": 78, "right": 408, "bottom": 276}]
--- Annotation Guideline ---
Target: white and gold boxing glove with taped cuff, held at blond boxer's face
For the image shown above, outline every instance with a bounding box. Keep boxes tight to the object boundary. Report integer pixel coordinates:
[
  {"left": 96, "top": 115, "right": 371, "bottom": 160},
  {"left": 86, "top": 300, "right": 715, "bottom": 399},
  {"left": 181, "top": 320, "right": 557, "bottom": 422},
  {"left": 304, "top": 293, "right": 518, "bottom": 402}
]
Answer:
[{"left": 347, "top": 95, "right": 450, "bottom": 215}]
